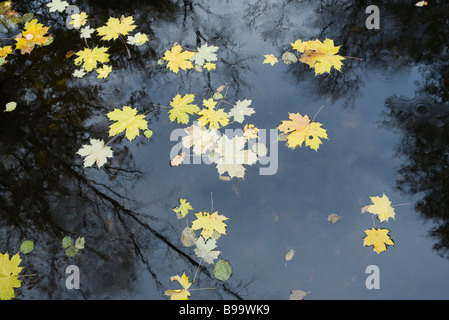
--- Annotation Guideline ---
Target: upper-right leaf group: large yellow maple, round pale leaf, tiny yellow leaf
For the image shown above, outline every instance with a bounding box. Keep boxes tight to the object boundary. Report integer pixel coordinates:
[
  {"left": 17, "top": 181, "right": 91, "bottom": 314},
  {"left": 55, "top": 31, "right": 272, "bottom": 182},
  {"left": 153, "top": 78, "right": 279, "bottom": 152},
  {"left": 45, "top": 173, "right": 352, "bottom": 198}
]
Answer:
[{"left": 263, "top": 38, "right": 346, "bottom": 75}]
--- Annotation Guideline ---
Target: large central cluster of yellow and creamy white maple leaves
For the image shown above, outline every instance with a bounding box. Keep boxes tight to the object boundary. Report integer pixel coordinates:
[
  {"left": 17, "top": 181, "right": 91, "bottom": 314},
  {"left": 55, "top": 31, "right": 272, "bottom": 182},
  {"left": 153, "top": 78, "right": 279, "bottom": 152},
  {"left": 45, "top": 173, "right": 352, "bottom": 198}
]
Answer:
[{"left": 168, "top": 88, "right": 262, "bottom": 178}]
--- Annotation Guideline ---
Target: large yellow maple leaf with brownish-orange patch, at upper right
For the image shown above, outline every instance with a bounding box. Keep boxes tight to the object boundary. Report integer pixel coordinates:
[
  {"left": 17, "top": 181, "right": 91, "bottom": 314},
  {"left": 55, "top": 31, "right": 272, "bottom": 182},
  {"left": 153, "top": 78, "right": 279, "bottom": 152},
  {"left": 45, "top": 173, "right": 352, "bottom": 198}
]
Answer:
[{"left": 291, "top": 38, "right": 345, "bottom": 75}]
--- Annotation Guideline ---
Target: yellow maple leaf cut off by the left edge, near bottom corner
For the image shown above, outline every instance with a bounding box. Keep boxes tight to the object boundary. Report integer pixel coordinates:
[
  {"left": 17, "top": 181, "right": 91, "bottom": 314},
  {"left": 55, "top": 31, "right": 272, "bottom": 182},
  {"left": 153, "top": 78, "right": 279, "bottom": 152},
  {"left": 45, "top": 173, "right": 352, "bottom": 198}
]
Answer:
[{"left": 0, "top": 252, "right": 23, "bottom": 300}]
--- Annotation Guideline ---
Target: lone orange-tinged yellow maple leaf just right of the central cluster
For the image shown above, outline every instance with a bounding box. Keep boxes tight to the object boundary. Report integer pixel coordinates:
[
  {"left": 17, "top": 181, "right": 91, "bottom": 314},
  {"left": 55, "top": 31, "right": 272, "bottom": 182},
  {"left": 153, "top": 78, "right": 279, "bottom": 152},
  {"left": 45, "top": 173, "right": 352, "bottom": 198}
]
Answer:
[{"left": 278, "top": 113, "right": 328, "bottom": 151}]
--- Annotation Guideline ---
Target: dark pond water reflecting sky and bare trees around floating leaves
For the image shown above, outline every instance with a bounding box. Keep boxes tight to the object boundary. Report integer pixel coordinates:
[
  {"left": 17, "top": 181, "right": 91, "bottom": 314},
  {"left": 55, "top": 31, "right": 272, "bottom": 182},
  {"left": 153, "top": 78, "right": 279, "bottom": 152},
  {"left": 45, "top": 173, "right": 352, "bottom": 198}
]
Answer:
[{"left": 0, "top": 0, "right": 449, "bottom": 300}]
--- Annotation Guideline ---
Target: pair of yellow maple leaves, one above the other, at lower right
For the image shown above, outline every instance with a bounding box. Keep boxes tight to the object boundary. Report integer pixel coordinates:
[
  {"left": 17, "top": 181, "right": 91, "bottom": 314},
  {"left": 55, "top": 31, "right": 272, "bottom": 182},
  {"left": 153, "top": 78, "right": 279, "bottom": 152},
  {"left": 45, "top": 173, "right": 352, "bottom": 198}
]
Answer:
[{"left": 362, "top": 193, "right": 395, "bottom": 254}]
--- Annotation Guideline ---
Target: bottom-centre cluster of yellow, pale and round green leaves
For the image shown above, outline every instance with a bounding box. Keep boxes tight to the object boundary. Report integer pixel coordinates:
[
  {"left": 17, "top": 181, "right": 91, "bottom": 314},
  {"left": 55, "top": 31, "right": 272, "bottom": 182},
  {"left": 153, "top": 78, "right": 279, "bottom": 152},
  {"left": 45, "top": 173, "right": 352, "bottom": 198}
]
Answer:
[{"left": 165, "top": 199, "right": 232, "bottom": 300}]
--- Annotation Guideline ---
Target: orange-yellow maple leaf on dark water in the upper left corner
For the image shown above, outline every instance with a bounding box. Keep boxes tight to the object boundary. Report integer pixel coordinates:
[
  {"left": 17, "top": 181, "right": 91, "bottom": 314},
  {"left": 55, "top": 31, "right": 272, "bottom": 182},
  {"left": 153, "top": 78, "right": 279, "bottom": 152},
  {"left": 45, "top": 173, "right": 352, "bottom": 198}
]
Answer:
[{"left": 15, "top": 19, "right": 50, "bottom": 54}]
